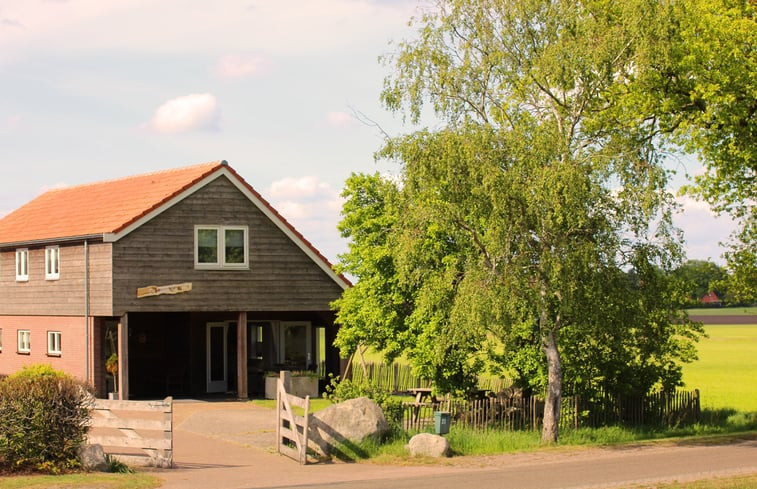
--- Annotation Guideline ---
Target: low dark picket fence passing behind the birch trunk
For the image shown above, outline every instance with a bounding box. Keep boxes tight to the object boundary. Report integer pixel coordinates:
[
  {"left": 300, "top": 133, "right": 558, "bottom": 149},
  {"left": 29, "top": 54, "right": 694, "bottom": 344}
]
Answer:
[{"left": 402, "top": 390, "right": 700, "bottom": 431}]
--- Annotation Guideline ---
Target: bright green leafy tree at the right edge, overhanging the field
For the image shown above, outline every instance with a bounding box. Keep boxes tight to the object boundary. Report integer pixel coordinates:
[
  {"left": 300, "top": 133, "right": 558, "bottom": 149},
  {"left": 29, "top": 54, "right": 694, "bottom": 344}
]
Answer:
[{"left": 617, "top": 0, "right": 757, "bottom": 302}]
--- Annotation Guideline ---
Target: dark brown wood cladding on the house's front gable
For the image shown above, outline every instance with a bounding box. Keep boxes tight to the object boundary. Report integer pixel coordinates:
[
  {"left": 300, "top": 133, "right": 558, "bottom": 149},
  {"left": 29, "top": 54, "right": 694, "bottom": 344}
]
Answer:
[{"left": 113, "top": 176, "right": 342, "bottom": 315}]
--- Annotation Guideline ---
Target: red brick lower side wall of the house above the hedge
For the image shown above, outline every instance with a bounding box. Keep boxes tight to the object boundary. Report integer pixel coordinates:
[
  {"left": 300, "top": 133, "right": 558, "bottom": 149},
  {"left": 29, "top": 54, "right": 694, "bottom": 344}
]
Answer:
[{"left": 0, "top": 316, "right": 94, "bottom": 382}]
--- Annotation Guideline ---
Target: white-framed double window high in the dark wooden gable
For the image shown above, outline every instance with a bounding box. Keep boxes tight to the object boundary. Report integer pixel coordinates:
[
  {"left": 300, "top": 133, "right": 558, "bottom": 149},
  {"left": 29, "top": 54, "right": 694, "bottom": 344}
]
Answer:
[{"left": 194, "top": 225, "right": 249, "bottom": 270}]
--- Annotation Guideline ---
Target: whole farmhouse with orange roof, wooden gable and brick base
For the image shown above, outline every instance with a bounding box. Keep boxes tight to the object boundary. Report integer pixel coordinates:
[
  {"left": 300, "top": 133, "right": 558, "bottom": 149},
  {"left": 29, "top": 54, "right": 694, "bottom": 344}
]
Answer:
[{"left": 0, "top": 161, "right": 349, "bottom": 399}]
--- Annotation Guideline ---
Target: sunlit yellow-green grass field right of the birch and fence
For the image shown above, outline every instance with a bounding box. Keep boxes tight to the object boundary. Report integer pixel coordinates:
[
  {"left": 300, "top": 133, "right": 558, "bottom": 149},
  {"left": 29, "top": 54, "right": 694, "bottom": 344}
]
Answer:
[{"left": 683, "top": 324, "right": 757, "bottom": 412}]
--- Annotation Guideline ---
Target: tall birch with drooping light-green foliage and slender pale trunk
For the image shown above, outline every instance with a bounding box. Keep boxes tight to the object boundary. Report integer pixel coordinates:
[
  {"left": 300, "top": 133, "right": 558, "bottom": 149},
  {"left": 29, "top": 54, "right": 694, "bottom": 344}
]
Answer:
[{"left": 383, "top": 0, "right": 704, "bottom": 441}]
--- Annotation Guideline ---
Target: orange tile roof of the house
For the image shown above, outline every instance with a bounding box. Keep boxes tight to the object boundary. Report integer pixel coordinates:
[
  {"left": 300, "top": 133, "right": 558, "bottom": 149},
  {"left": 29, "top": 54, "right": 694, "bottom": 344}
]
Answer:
[{"left": 0, "top": 161, "right": 225, "bottom": 243}]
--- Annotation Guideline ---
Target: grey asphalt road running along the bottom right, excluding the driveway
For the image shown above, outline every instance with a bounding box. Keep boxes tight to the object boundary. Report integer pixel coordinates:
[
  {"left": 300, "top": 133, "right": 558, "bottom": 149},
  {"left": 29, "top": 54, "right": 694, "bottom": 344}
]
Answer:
[{"left": 258, "top": 440, "right": 757, "bottom": 489}]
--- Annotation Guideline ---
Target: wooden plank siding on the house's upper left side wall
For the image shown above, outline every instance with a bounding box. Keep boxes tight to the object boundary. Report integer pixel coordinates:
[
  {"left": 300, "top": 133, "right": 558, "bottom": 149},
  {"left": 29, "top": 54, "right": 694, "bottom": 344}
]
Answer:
[{"left": 0, "top": 243, "right": 113, "bottom": 316}]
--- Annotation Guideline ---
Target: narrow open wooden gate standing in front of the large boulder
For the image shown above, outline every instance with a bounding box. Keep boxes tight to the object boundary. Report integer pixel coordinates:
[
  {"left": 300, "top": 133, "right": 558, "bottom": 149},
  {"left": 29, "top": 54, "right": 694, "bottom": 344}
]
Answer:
[{"left": 276, "top": 371, "right": 310, "bottom": 465}]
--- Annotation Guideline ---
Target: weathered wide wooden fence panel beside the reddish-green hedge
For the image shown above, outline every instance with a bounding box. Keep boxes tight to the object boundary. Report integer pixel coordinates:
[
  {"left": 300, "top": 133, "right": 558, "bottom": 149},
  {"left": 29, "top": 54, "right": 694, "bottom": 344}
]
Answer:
[{"left": 87, "top": 397, "right": 173, "bottom": 468}]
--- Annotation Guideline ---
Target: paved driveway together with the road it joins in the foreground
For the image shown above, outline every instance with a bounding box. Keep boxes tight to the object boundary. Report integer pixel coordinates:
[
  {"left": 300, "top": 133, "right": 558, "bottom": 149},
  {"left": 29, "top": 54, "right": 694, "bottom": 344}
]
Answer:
[{"left": 156, "top": 403, "right": 757, "bottom": 489}]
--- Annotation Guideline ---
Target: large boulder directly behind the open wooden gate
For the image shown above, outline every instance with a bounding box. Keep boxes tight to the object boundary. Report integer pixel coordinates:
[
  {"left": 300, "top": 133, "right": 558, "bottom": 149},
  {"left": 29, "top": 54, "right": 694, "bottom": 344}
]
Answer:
[{"left": 310, "top": 397, "right": 389, "bottom": 455}]
